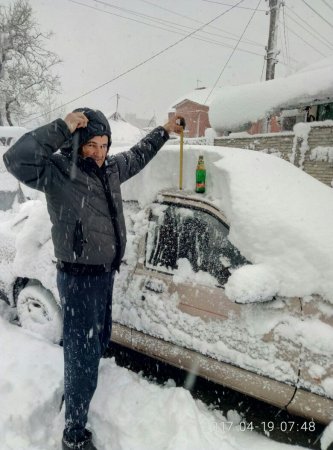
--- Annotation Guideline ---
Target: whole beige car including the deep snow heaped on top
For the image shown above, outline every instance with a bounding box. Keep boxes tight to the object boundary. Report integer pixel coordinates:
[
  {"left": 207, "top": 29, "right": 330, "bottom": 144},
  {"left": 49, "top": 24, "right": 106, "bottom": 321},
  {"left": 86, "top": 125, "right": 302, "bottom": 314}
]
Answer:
[{"left": 0, "top": 146, "right": 333, "bottom": 426}]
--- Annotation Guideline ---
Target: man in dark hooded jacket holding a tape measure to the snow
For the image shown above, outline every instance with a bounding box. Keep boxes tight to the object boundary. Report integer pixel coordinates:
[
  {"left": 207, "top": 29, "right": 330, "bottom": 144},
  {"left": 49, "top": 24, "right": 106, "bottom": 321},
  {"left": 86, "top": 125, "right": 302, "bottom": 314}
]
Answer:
[{"left": 4, "top": 108, "right": 182, "bottom": 450}]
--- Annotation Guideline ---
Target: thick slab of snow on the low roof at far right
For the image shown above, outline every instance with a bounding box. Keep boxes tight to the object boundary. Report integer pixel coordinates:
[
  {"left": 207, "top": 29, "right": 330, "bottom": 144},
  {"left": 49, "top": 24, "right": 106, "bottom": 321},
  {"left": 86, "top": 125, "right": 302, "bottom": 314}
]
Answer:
[{"left": 209, "top": 56, "right": 333, "bottom": 133}]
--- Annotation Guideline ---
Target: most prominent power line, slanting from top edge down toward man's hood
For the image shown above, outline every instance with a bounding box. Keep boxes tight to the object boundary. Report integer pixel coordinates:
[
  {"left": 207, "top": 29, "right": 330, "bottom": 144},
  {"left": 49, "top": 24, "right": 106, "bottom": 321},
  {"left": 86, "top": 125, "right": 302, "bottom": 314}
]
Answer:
[{"left": 23, "top": 0, "right": 244, "bottom": 125}]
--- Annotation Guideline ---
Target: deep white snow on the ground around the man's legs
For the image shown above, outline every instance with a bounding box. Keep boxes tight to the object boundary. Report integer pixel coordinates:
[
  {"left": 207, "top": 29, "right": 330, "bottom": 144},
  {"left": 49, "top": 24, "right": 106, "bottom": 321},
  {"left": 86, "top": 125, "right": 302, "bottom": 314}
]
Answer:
[{"left": 0, "top": 305, "right": 312, "bottom": 450}]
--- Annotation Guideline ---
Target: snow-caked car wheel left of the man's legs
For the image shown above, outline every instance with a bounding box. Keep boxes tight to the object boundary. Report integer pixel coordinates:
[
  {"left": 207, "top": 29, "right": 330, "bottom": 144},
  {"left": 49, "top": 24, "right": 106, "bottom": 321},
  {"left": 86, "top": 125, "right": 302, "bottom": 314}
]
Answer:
[{"left": 16, "top": 285, "right": 62, "bottom": 343}]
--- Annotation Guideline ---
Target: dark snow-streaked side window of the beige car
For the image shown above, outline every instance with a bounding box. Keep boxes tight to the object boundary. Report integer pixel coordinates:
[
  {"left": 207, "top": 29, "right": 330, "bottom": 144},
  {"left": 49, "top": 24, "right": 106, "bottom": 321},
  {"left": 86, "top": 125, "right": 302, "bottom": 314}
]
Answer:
[{"left": 146, "top": 205, "right": 248, "bottom": 285}]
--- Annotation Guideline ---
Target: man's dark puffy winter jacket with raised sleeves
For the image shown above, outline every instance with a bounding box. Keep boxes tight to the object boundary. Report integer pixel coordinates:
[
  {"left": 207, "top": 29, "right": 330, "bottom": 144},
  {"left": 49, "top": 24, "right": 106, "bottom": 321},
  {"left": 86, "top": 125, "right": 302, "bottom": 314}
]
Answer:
[{"left": 4, "top": 119, "right": 169, "bottom": 270}]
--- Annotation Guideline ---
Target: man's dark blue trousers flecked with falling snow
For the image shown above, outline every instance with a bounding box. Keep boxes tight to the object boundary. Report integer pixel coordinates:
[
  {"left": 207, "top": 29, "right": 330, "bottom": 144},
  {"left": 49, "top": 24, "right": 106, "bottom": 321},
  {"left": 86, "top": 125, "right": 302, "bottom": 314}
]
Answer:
[{"left": 57, "top": 270, "right": 114, "bottom": 443}]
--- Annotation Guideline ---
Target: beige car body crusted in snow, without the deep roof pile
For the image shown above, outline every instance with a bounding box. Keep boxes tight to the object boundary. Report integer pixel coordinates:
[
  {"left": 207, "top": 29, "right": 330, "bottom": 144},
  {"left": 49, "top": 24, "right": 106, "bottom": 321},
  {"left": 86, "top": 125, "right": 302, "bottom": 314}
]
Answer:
[{"left": 0, "top": 193, "right": 333, "bottom": 422}]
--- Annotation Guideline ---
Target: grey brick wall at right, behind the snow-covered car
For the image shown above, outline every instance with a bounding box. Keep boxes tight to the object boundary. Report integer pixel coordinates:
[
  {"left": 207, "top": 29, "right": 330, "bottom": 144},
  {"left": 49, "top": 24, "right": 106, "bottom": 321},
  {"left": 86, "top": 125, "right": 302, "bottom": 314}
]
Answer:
[{"left": 214, "top": 120, "right": 333, "bottom": 187}]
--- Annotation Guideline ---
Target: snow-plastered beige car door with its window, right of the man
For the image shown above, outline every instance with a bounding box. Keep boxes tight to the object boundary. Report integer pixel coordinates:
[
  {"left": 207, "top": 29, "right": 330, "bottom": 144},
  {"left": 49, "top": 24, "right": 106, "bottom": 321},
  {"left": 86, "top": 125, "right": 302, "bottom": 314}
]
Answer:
[{"left": 126, "top": 195, "right": 301, "bottom": 385}]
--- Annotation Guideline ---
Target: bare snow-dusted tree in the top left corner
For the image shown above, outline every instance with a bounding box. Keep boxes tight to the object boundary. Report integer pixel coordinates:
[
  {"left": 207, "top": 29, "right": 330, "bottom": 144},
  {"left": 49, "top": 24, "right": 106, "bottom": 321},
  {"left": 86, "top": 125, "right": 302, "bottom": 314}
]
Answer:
[{"left": 0, "top": 0, "right": 60, "bottom": 125}]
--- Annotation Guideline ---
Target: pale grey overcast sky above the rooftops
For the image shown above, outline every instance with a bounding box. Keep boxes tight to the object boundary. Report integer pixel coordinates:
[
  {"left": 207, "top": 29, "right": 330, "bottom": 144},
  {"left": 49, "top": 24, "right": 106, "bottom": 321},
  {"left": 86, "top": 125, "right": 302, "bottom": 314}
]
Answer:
[{"left": 1, "top": 0, "right": 333, "bottom": 123}]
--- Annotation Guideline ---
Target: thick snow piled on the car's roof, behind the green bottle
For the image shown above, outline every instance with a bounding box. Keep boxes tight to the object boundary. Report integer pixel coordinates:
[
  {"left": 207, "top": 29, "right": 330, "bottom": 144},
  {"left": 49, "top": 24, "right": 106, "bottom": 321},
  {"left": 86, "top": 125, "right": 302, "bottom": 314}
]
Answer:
[{"left": 122, "top": 145, "right": 333, "bottom": 302}]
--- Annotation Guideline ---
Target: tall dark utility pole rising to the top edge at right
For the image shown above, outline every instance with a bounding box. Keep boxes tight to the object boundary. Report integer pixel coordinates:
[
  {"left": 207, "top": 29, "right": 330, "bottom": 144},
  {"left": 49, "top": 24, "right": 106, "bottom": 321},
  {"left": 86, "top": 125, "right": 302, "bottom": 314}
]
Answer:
[{"left": 265, "top": 0, "right": 282, "bottom": 80}]
